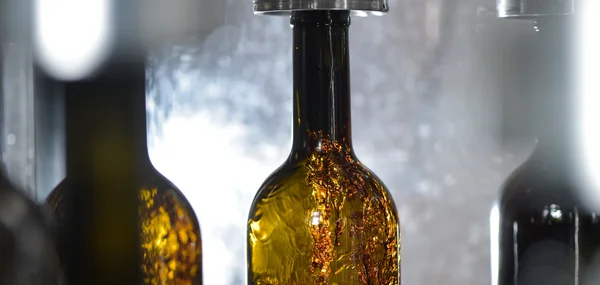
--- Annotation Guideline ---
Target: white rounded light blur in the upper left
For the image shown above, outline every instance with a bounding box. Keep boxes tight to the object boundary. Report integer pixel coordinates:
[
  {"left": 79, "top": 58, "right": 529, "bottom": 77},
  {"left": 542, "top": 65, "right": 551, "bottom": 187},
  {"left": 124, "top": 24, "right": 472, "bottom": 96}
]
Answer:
[{"left": 34, "top": 0, "right": 112, "bottom": 80}]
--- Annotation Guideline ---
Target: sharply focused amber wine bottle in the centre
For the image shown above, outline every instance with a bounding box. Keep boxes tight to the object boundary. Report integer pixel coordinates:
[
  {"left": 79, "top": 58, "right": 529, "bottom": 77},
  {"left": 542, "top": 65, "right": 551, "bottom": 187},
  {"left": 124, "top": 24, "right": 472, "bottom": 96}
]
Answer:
[{"left": 247, "top": 10, "right": 400, "bottom": 284}]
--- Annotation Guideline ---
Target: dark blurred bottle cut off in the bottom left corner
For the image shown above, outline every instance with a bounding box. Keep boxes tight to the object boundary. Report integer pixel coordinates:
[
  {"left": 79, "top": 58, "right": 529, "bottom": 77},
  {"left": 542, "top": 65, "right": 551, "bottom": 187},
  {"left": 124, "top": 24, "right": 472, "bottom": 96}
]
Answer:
[{"left": 0, "top": 70, "right": 61, "bottom": 285}]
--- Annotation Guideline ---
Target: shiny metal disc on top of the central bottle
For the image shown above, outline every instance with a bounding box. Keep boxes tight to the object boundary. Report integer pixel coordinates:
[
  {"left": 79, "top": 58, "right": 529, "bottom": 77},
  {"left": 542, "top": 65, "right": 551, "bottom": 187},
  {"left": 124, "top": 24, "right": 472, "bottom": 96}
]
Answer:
[{"left": 254, "top": 0, "right": 389, "bottom": 17}]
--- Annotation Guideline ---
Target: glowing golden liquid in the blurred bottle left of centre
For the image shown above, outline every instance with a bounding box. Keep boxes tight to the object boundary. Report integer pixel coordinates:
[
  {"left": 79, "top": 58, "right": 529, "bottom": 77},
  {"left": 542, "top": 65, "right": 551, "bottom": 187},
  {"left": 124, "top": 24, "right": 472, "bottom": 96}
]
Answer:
[{"left": 46, "top": 173, "right": 202, "bottom": 285}]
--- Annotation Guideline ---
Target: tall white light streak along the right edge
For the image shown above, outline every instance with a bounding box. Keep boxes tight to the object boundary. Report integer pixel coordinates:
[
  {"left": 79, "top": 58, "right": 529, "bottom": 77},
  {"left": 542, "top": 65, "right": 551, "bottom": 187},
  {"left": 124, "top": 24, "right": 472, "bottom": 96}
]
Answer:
[{"left": 575, "top": 1, "right": 600, "bottom": 209}]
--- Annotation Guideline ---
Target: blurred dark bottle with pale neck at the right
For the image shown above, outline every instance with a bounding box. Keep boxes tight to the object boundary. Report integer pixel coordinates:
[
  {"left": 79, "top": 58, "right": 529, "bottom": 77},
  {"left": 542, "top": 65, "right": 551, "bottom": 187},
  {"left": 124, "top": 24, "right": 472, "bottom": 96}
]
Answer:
[{"left": 490, "top": 16, "right": 600, "bottom": 285}]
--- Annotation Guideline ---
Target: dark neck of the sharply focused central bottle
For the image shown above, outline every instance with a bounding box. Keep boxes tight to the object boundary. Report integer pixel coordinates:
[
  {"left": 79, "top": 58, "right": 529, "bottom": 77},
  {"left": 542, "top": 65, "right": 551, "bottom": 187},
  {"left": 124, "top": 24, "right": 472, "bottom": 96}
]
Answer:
[{"left": 291, "top": 11, "right": 352, "bottom": 157}]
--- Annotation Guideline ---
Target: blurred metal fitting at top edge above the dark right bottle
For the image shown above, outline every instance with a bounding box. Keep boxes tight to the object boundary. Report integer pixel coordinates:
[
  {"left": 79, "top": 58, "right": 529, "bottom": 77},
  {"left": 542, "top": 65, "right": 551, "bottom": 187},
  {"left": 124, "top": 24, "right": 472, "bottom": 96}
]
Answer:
[{"left": 496, "top": 0, "right": 576, "bottom": 20}]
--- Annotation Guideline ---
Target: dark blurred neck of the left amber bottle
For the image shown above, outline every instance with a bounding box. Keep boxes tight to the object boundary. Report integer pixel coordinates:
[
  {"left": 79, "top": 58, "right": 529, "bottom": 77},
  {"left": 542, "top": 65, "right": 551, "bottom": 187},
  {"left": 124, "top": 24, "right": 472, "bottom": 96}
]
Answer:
[{"left": 64, "top": 58, "right": 150, "bottom": 173}]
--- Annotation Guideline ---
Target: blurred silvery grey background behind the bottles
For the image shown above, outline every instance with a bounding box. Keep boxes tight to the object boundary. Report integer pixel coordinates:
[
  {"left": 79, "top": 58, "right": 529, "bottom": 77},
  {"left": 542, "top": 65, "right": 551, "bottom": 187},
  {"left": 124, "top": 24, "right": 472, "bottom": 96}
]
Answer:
[{"left": 0, "top": 0, "right": 556, "bottom": 285}]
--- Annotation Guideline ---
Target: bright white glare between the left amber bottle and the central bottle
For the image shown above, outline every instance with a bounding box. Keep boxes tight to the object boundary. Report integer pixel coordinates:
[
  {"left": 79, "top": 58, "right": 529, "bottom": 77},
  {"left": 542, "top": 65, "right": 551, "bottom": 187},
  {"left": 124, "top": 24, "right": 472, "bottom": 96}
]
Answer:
[{"left": 149, "top": 108, "right": 288, "bottom": 285}]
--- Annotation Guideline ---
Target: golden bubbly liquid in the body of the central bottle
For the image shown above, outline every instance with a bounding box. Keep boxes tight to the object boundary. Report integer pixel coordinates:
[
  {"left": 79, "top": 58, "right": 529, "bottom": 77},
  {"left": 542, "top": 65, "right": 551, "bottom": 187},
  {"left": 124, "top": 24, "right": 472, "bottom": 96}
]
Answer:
[{"left": 248, "top": 134, "right": 400, "bottom": 284}]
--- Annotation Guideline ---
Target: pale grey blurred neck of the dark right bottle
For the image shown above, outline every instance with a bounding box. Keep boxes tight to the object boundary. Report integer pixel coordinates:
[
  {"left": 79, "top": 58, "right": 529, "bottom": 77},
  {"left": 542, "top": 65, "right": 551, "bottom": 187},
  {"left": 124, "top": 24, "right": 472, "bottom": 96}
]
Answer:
[{"left": 532, "top": 17, "right": 576, "bottom": 158}]
